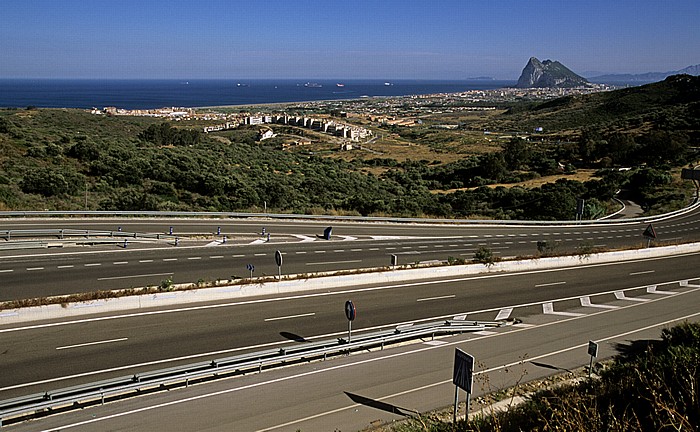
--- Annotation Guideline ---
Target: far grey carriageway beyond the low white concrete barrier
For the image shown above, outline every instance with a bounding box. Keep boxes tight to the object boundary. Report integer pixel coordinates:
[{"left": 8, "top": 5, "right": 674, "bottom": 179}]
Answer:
[{"left": 0, "top": 210, "right": 700, "bottom": 301}]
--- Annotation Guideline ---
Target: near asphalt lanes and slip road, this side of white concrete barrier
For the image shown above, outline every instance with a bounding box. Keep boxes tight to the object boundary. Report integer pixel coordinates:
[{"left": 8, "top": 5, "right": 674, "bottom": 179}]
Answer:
[{"left": 0, "top": 254, "right": 700, "bottom": 431}]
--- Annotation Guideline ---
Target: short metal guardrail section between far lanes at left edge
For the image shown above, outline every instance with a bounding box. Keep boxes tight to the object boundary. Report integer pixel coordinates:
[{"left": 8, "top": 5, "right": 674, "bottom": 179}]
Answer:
[{"left": 0, "top": 228, "right": 177, "bottom": 247}]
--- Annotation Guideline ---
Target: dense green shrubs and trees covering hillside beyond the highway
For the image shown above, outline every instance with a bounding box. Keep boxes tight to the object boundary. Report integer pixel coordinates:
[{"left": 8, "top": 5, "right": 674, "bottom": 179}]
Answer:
[{"left": 0, "top": 78, "right": 700, "bottom": 219}]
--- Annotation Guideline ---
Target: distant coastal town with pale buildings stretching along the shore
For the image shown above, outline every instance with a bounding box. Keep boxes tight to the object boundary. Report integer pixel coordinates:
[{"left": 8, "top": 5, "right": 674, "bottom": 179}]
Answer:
[{"left": 90, "top": 84, "right": 614, "bottom": 150}]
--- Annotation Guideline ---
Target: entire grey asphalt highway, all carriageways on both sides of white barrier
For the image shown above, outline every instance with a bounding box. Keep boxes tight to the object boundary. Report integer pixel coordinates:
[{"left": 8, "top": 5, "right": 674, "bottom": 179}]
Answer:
[{"left": 0, "top": 209, "right": 700, "bottom": 430}]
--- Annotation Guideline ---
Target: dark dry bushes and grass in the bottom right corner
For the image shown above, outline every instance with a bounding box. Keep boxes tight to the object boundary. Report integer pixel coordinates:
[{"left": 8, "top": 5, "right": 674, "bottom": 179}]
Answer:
[{"left": 393, "top": 323, "right": 700, "bottom": 432}]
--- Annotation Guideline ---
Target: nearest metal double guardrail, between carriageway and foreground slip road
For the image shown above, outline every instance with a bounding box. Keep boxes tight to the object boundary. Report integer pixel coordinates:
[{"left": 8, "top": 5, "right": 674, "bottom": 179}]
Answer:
[{"left": 0, "top": 320, "right": 505, "bottom": 426}]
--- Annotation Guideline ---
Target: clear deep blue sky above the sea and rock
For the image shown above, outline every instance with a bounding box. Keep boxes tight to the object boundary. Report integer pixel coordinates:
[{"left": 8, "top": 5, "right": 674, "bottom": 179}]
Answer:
[{"left": 0, "top": 0, "right": 700, "bottom": 79}]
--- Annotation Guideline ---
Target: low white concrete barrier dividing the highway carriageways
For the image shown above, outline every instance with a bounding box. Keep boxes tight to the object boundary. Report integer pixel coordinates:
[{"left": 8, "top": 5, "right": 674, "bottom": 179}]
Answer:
[{"left": 0, "top": 243, "right": 700, "bottom": 325}]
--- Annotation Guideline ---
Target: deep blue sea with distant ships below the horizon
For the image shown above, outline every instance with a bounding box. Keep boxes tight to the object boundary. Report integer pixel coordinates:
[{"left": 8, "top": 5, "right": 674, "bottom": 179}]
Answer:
[{"left": 0, "top": 79, "right": 515, "bottom": 109}]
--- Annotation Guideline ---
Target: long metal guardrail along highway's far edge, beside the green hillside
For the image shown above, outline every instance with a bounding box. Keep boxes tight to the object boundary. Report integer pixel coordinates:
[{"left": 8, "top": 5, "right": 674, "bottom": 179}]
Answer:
[{"left": 0, "top": 197, "right": 700, "bottom": 228}]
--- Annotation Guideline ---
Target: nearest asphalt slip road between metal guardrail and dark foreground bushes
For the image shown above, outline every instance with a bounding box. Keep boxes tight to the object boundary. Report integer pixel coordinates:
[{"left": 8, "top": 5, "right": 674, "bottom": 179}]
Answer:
[{"left": 7, "top": 264, "right": 700, "bottom": 431}]
